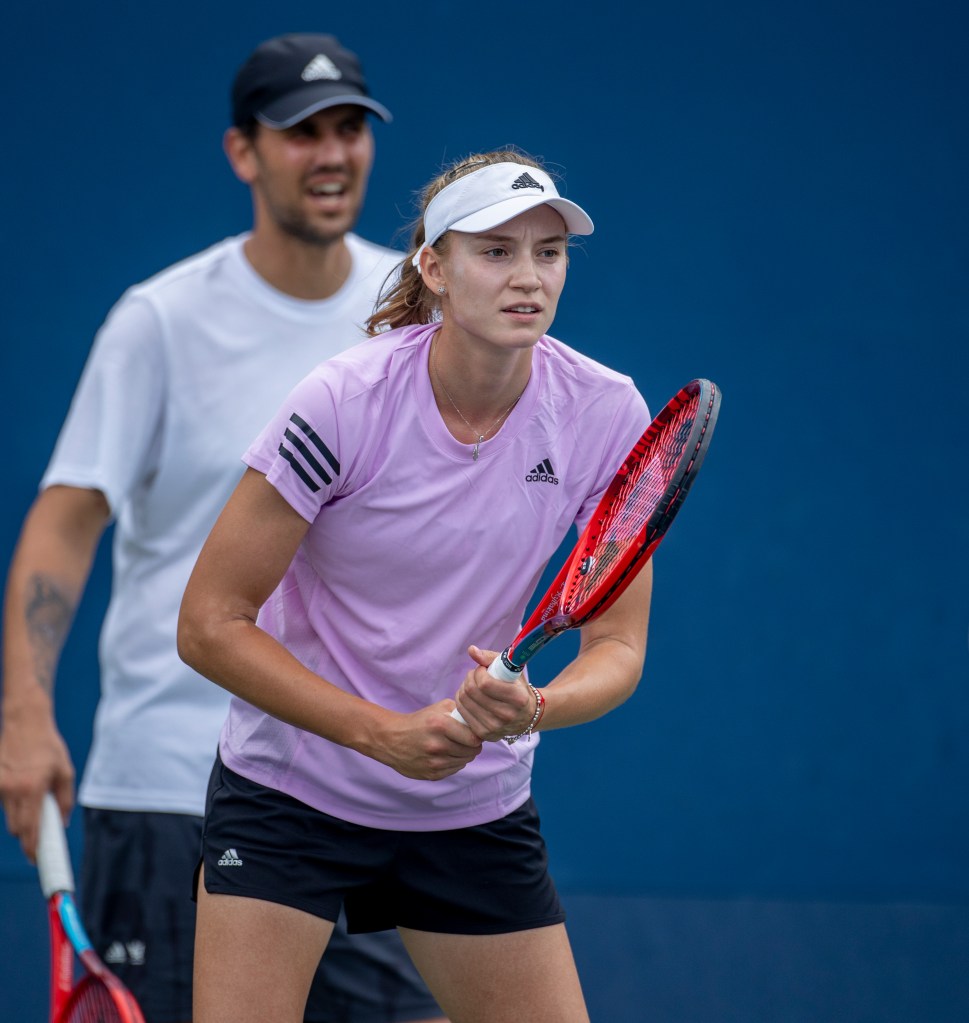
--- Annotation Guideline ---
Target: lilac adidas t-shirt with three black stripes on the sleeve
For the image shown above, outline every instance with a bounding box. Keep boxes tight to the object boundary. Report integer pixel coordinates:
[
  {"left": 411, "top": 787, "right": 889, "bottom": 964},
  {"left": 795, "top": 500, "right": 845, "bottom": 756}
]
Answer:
[{"left": 221, "top": 325, "right": 650, "bottom": 831}]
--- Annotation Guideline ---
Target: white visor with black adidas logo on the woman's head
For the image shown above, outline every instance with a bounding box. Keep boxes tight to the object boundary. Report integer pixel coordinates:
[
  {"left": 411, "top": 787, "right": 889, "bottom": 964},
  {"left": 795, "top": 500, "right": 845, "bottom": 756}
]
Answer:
[{"left": 411, "top": 164, "right": 593, "bottom": 268}]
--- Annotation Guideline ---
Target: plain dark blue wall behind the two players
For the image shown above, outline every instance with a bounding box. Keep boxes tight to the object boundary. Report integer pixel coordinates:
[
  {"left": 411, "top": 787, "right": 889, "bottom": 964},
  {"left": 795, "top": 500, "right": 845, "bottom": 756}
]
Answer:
[{"left": 0, "top": 0, "right": 969, "bottom": 1023}]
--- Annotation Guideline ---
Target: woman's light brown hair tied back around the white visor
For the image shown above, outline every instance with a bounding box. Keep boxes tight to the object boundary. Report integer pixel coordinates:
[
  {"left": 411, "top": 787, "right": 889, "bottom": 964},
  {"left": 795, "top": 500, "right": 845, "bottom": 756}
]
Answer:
[{"left": 366, "top": 146, "right": 548, "bottom": 337}]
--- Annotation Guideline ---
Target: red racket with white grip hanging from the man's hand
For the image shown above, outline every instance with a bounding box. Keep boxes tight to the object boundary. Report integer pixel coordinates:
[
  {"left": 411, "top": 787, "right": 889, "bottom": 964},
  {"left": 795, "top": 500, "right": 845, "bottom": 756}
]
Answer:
[{"left": 37, "top": 794, "right": 144, "bottom": 1023}]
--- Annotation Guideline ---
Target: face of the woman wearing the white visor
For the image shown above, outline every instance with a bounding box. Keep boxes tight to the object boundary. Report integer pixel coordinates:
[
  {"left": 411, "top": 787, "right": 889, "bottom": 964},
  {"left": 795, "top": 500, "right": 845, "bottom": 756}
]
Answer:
[{"left": 440, "top": 206, "right": 568, "bottom": 349}]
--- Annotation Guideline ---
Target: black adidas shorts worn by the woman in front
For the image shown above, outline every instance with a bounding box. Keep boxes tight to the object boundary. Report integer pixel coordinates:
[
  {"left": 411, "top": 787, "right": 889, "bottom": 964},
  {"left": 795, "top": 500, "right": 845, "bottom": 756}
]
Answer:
[{"left": 203, "top": 761, "right": 565, "bottom": 934}]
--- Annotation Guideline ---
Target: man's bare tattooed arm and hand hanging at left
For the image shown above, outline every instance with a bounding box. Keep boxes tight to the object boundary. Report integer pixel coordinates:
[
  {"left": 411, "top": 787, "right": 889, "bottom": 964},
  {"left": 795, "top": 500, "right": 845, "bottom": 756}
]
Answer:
[{"left": 0, "top": 486, "right": 111, "bottom": 859}]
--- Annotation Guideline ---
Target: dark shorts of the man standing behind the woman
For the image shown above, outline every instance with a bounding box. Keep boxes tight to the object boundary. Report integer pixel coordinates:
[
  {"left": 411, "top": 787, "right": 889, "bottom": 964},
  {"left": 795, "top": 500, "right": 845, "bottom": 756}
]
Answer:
[{"left": 78, "top": 809, "right": 441, "bottom": 1023}]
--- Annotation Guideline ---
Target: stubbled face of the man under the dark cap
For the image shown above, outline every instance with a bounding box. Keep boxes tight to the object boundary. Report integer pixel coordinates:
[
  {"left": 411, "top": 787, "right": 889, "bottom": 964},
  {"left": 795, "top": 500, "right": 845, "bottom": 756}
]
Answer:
[{"left": 236, "top": 104, "right": 373, "bottom": 246}]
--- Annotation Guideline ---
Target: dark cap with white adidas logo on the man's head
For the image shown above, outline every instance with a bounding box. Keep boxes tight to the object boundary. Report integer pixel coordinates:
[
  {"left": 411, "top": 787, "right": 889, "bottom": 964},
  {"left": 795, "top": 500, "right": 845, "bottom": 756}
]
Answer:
[{"left": 232, "top": 33, "right": 391, "bottom": 129}]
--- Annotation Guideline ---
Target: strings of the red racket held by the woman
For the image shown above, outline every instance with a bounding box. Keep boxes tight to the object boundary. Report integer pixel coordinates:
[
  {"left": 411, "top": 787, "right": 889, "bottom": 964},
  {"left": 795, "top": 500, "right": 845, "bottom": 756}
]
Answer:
[{"left": 563, "top": 396, "right": 698, "bottom": 613}]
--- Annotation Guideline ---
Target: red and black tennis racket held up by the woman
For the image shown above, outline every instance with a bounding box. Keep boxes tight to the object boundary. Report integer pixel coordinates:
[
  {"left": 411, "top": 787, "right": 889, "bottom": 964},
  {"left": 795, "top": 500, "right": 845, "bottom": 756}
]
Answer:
[{"left": 451, "top": 380, "right": 720, "bottom": 721}]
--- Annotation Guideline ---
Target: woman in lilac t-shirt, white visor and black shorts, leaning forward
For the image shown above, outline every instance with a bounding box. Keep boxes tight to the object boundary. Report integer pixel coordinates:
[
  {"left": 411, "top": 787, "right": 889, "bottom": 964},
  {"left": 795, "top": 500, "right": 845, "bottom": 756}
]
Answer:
[{"left": 179, "top": 149, "right": 651, "bottom": 1023}]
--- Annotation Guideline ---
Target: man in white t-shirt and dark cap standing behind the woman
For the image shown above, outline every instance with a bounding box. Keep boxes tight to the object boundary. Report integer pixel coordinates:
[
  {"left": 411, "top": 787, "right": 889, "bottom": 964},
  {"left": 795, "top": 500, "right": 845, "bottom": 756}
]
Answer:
[{"left": 0, "top": 35, "right": 440, "bottom": 1023}]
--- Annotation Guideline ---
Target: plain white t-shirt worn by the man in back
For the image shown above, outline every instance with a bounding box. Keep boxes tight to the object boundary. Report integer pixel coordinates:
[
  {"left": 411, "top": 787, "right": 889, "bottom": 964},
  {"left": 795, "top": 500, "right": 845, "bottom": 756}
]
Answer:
[{"left": 41, "top": 235, "right": 400, "bottom": 814}]
